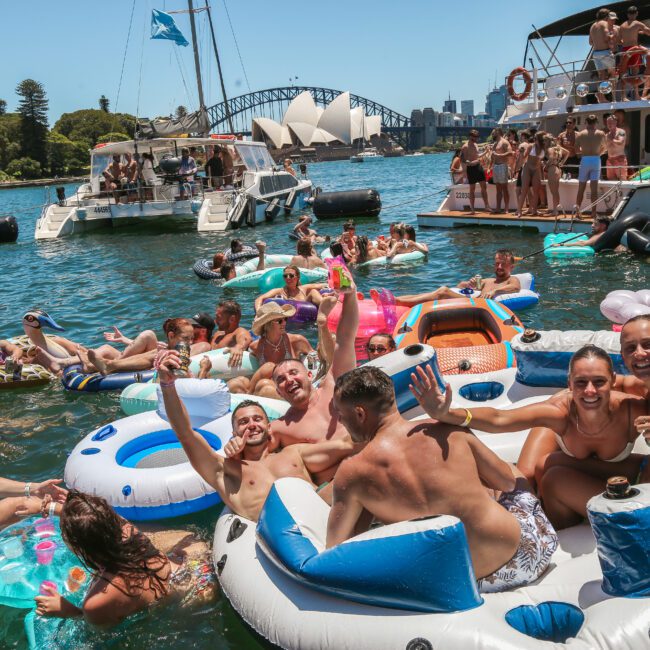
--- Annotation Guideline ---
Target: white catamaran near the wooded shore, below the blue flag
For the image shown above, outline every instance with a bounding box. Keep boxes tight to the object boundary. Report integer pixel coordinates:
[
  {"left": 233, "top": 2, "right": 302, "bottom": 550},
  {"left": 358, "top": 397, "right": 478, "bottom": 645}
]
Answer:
[{"left": 35, "top": 136, "right": 312, "bottom": 240}]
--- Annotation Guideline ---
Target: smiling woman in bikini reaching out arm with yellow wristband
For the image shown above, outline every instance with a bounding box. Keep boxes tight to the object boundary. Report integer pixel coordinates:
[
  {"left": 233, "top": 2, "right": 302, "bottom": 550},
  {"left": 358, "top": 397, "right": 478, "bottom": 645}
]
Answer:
[{"left": 412, "top": 345, "right": 650, "bottom": 528}]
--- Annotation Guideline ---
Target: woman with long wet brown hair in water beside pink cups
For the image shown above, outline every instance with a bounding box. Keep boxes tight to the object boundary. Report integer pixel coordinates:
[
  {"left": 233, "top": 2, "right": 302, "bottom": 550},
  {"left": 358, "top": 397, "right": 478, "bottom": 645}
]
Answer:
[{"left": 35, "top": 490, "right": 216, "bottom": 626}]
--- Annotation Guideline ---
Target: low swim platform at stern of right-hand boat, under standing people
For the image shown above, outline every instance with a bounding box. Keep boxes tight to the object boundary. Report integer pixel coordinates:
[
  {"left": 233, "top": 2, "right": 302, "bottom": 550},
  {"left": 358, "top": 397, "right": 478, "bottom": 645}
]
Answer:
[{"left": 418, "top": 209, "right": 591, "bottom": 233}]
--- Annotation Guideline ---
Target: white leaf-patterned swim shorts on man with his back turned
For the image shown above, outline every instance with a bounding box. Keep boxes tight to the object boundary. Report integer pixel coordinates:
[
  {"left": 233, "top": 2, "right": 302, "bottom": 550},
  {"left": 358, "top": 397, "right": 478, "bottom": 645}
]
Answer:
[{"left": 478, "top": 490, "right": 558, "bottom": 594}]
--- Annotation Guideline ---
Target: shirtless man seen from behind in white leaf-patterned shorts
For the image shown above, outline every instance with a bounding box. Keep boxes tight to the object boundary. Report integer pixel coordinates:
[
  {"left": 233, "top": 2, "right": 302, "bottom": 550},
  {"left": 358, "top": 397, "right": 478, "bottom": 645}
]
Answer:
[{"left": 327, "top": 366, "right": 557, "bottom": 592}]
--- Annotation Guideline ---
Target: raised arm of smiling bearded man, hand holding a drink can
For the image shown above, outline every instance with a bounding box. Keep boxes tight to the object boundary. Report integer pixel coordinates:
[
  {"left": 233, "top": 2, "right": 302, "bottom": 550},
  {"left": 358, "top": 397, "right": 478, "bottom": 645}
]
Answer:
[{"left": 154, "top": 350, "right": 224, "bottom": 486}]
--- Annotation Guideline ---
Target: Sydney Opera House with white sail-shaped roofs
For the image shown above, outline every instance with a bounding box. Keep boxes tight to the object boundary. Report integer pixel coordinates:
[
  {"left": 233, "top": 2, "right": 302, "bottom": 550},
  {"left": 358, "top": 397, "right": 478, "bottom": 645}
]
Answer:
[{"left": 252, "top": 91, "right": 381, "bottom": 158}]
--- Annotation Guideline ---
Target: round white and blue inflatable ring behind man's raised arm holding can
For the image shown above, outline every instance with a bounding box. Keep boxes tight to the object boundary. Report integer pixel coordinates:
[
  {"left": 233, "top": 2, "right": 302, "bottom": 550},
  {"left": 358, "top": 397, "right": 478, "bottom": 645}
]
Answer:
[{"left": 64, "top": 379, "right": 232, "bottom": 521}]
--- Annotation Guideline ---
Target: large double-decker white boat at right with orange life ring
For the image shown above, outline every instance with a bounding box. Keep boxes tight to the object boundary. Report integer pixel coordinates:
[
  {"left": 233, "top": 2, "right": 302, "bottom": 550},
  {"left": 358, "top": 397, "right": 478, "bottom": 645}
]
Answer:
[{"left": 418, "top": 2, "right": 650, "bottom": 234}]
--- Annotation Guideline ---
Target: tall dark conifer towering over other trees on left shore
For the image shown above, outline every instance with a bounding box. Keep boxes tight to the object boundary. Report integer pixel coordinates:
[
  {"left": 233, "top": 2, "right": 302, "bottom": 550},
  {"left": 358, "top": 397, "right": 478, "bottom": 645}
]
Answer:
[{"left": 16, "top": 79, "right": 48, "bottom": 168}]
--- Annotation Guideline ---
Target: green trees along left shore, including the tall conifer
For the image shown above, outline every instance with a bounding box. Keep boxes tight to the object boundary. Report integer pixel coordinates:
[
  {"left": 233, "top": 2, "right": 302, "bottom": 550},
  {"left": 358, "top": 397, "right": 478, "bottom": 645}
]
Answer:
[{"left": 0, "top": 79, "right": 135, "bottom": 182}]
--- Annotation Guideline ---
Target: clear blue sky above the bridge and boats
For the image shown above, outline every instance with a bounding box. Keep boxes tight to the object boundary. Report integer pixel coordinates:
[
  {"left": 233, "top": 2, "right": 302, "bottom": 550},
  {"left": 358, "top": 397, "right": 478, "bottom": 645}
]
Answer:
[{"left": 0, "top": 0, "right": 598, "bottom": 124}]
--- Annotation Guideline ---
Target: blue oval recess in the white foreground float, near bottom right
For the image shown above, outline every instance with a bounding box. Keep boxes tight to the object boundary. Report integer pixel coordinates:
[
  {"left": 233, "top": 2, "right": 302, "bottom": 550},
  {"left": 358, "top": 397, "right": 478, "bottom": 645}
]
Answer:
[{"left": 506, "top": 601, "right": 585, "bottom": 643}]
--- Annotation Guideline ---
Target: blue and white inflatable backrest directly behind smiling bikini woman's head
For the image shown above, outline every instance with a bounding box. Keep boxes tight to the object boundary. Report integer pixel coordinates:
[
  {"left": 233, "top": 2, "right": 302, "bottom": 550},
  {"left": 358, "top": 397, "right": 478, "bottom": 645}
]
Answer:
[{"left": 511, "top": 330, "right": 629, "bottom": 388}]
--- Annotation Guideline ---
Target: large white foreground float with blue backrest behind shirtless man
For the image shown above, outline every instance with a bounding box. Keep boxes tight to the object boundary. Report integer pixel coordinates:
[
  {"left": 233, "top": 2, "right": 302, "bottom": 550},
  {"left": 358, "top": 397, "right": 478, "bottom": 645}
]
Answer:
[{"left": 213, "top": 470, "right": 650, "bottom": 650}]
